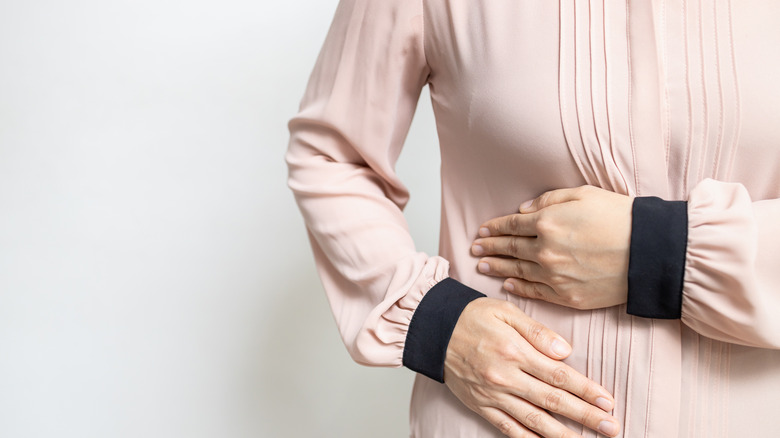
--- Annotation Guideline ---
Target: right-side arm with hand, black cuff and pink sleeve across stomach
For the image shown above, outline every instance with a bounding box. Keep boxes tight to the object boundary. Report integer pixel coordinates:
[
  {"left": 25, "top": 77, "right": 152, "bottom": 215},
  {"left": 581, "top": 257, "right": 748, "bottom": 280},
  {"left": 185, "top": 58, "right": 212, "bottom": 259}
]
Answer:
[{"left": 475, "top": 179, "right": 780, "bottom": 348}]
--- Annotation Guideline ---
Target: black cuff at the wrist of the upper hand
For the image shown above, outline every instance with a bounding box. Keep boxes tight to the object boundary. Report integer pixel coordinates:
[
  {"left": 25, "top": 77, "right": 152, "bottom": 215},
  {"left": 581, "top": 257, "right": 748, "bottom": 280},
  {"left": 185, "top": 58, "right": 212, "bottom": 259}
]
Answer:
[{"left": 627, "top": 197, "right": 688, "bottom": 319}]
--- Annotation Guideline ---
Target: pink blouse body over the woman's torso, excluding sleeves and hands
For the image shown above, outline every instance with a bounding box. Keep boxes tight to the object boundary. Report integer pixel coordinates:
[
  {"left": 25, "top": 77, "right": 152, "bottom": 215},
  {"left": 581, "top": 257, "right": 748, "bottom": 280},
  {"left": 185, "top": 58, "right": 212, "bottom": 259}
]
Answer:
[{"left": 412, "top": 0, "right": 780, "bottom": 438}]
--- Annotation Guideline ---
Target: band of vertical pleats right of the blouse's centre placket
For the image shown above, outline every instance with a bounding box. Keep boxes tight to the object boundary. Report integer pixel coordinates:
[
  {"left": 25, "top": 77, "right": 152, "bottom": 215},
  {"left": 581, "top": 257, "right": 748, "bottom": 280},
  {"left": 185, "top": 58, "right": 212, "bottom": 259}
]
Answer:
[{"left": 664, "top": 0, "right": 741, "bottom": 199}]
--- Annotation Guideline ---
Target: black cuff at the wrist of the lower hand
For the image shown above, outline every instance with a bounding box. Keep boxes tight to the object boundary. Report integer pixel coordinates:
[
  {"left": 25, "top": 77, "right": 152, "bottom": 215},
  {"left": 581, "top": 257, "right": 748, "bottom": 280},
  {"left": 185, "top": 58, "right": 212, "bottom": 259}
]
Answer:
[{"left": 403, "top": 278, "right": 485, "bottom": 383}]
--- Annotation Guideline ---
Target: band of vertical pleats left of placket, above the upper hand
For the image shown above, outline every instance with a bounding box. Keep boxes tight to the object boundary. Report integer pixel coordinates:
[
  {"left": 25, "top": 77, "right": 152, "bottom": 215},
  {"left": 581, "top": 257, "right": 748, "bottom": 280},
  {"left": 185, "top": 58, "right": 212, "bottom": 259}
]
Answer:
[{"left": 558, "top": 0, "right": 634, "bottom": 194}]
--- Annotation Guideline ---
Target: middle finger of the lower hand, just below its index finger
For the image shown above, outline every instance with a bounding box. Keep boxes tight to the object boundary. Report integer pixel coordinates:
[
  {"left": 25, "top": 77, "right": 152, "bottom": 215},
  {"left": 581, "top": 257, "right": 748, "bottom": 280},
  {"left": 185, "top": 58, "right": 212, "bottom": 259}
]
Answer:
[{"left": 518, "top": 379, "right": 620, "bottom": 436}]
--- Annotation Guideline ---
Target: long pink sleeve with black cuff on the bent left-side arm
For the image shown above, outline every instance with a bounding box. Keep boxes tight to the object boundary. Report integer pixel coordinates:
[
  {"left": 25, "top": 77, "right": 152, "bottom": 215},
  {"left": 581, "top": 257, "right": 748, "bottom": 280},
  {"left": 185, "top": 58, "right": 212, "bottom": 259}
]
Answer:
[{"left": 285, "top": 0, "right": 479, "bottom": 380}]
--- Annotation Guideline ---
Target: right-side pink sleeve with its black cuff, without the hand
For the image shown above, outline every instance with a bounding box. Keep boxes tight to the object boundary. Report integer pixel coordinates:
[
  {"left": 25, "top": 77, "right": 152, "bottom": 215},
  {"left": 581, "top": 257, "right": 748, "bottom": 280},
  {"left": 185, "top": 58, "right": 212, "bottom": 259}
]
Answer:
[{"left": 628, "top": 179, "right": 780, "bottom": 349}]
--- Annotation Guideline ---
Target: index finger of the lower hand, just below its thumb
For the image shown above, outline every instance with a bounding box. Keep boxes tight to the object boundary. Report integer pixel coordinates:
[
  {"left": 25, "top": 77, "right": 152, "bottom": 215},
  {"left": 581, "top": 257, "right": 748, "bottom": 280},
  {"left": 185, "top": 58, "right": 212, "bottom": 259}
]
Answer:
[{"left": 521, "top": 355, "right": 615, "bottom": 418}]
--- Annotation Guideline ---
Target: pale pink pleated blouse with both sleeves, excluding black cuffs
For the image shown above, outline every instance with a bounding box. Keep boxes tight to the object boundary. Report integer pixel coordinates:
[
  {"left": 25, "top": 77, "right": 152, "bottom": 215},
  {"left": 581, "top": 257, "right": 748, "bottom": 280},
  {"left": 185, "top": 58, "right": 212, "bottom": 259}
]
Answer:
[{"left": 286, "top": 0, "right": 780, "bottom": 438}]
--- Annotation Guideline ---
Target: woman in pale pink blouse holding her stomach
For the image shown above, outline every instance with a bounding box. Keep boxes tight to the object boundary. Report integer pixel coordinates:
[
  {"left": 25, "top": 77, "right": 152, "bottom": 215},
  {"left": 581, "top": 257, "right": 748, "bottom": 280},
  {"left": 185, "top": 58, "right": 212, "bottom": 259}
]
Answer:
[{"left": 286, "top": 0, "right": 780, "bottom": 438}]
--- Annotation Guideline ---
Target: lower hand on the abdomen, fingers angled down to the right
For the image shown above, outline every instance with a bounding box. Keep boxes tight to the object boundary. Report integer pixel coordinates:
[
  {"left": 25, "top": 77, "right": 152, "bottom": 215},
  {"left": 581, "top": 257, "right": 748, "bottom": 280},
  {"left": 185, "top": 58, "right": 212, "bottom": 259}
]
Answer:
[{"left": 444, "top": 298, "right": 620, "bottom": 438}]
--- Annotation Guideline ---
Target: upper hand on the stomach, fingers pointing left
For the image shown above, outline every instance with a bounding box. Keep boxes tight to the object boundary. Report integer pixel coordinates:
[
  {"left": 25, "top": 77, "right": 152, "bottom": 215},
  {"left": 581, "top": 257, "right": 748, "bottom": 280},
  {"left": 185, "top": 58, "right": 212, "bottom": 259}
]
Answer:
[{"left": 471, "top": 186, "right": 633, "bottom": 309}]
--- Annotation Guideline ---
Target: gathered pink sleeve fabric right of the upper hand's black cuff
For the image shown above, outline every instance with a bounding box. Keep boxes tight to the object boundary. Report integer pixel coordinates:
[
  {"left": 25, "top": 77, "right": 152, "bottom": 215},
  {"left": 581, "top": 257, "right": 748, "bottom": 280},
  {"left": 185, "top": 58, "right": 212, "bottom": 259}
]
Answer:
[{"left": 682, "top": 179, "right": 780, "bottom": 349}]
